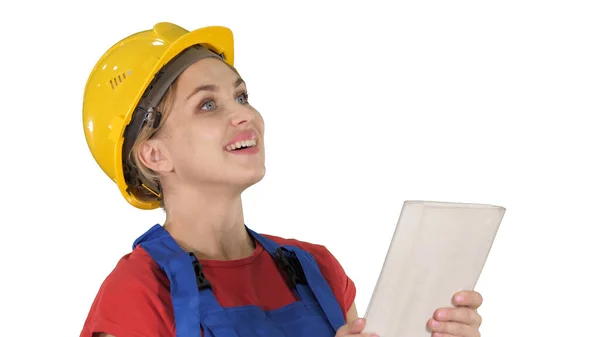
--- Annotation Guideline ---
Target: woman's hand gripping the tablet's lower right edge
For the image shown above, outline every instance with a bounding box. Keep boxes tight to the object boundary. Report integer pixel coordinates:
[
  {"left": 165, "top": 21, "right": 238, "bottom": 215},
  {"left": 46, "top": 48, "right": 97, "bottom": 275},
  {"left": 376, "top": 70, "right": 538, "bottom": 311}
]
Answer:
[{"left": 427, "top": 291, "right": 483, "bottom": 337}]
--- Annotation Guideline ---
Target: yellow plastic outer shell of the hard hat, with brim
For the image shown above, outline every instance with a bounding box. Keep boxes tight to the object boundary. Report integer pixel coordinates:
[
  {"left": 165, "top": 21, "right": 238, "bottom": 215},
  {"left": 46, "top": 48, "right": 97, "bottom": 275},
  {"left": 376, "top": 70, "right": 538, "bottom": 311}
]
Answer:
[{"left": 83, "top": 22, "right": 234, "bottom": 210}]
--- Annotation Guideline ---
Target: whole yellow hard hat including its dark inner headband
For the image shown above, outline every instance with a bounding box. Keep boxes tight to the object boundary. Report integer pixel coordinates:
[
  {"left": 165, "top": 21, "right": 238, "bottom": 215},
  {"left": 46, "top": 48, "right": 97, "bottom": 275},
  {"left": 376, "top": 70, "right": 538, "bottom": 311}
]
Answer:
[{"left": 83, "top": 22, "right": 234, "bottom": 209}]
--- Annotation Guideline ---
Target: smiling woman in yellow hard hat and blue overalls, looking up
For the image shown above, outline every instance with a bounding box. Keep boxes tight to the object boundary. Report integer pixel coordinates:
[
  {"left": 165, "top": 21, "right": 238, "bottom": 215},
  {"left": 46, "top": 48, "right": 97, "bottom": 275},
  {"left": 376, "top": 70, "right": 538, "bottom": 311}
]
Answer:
[{"left": 81, "top": 23, "right": 481, "bottom": 337}]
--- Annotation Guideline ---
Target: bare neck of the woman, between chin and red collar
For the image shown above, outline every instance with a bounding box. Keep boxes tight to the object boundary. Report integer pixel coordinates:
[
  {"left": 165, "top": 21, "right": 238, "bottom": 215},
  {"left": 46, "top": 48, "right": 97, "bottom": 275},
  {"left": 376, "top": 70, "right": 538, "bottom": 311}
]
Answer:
[{"left": 164, "top": 184, "right": 254, "bottom": 260}]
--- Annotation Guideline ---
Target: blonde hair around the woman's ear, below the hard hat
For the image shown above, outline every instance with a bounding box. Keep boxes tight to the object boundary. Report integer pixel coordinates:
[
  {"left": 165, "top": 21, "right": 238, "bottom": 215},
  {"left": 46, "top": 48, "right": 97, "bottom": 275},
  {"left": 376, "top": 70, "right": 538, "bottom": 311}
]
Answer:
[{"left": 127, "top": 80, "right": 178, "bottom": 210}]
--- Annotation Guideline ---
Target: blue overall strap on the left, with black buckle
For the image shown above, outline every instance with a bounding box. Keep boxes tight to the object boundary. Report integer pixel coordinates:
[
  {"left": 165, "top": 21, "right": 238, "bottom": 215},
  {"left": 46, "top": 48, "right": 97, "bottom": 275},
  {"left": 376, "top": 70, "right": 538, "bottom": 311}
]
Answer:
[{"left": 133, "top": 224, "right": 222, "bottom": 337}]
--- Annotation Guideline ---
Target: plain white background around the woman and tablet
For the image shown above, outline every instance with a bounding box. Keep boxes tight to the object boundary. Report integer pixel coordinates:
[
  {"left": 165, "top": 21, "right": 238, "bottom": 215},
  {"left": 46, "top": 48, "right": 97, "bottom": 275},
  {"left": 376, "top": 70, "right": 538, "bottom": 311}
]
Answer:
[{"left": 0, "top": 0, "right": 600, "bottom": 337}]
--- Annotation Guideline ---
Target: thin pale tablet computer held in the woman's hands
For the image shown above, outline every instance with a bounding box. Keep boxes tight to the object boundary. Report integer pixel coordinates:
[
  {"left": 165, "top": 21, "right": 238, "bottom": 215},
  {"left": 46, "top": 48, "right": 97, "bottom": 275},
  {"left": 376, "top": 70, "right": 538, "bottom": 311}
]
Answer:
[{"left": 363, "top": 200, "right": 505, "bottom": 337}]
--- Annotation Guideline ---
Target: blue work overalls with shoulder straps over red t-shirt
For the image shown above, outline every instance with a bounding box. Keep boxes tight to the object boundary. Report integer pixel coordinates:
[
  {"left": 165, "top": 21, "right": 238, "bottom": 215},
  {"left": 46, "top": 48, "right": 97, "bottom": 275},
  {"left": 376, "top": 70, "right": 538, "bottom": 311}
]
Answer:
[{"left": 133, "top": 224, "right": 345, "bottom": 337}]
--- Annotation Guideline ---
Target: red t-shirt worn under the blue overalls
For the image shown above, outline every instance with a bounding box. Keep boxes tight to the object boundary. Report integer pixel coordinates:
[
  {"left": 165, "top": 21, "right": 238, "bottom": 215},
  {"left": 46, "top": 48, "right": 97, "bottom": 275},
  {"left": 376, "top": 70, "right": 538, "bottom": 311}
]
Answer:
[{"left": 80, "top": 235, "right": 356, "bottom": 337}]
